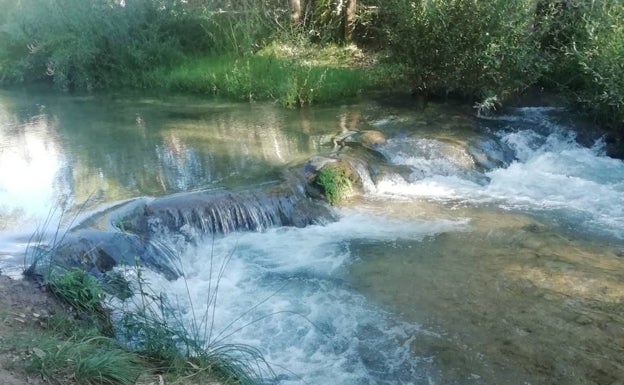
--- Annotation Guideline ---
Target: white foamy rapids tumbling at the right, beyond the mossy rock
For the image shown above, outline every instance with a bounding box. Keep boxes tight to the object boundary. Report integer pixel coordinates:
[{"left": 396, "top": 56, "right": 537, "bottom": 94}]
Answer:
[{"left": 375, "top": 109, "right": 624, "bottom": 238}]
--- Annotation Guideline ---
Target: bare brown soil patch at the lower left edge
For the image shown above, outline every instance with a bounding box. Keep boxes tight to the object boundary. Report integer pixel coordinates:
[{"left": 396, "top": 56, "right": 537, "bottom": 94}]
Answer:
[{"left": 0, "top": 276, "right": 69, "bottom": 385}]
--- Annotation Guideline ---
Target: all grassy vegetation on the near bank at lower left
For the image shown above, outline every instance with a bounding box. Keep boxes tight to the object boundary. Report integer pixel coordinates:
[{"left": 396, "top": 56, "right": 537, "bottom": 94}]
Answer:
[{"left": 18, "top": 250, "right": 273, "bottom": 385}]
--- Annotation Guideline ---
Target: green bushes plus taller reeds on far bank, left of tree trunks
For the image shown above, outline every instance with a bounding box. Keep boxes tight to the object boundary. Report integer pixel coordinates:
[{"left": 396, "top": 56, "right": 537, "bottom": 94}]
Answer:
[{"left": 0, "top": 0, "right": 280, "bottom": 90}]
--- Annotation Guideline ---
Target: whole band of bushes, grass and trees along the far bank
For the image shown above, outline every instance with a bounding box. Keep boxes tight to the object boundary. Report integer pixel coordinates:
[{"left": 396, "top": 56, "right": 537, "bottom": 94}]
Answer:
[{"left": 0, "top": 0, "right": 624, "bottom": 130}]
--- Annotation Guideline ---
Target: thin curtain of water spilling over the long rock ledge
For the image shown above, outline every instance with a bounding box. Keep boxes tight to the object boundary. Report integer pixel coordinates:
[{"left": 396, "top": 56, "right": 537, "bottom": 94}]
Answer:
[{"left": 120, "top": 187, "right": 332, "bottom": 241}]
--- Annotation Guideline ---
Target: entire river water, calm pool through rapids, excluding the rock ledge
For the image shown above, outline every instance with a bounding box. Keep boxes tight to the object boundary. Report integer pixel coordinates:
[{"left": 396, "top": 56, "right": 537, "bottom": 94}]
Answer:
[{"left": 0, "top": 88, "right": 624, "bottom": 385}]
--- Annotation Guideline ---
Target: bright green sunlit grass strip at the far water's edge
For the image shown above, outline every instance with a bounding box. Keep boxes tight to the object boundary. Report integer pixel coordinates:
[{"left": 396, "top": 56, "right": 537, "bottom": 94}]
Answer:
[{"left": 154, "top": 52, "right": 372, "bottom": 107}]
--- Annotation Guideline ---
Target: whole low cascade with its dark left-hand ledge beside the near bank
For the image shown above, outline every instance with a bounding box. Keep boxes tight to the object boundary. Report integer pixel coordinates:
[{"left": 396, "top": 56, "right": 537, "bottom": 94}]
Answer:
[{"left": 33, "top": 180, "right": 335, "bottom": 279}]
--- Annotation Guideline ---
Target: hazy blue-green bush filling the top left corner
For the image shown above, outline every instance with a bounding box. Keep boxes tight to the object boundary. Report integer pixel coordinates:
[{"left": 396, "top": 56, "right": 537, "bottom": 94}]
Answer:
[{"left": 0, "top": 0, "right": 189, "bottom": 90}]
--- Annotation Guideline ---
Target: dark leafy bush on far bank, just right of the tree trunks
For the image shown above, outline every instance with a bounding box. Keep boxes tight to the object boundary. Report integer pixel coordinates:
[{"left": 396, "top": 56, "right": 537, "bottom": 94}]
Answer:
[{"left": 380, "top": 0, "right": 544, "bottom": 99}]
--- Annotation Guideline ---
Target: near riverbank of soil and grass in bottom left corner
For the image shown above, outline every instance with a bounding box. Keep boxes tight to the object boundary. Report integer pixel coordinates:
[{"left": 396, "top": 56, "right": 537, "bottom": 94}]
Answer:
[{"left": 0, "top": 276, "right": 228, "bottom": 385}]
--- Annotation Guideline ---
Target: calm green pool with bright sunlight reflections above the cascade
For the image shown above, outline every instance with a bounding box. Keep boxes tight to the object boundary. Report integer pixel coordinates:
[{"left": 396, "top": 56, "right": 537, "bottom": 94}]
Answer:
[{"left": 0, "top": 93, "right": 358, "bottom": 219}]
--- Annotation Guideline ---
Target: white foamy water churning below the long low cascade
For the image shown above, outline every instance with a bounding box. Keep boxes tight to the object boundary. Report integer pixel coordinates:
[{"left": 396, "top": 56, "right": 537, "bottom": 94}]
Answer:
[{"left": 118, "top": 211, "right": 467, "bottom": 385}]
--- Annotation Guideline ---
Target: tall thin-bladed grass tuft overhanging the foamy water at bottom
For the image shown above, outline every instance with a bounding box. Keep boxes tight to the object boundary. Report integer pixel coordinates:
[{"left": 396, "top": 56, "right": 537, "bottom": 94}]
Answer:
[{"left": 116, "top": 257, "right": 274, "bottom": 385}]
